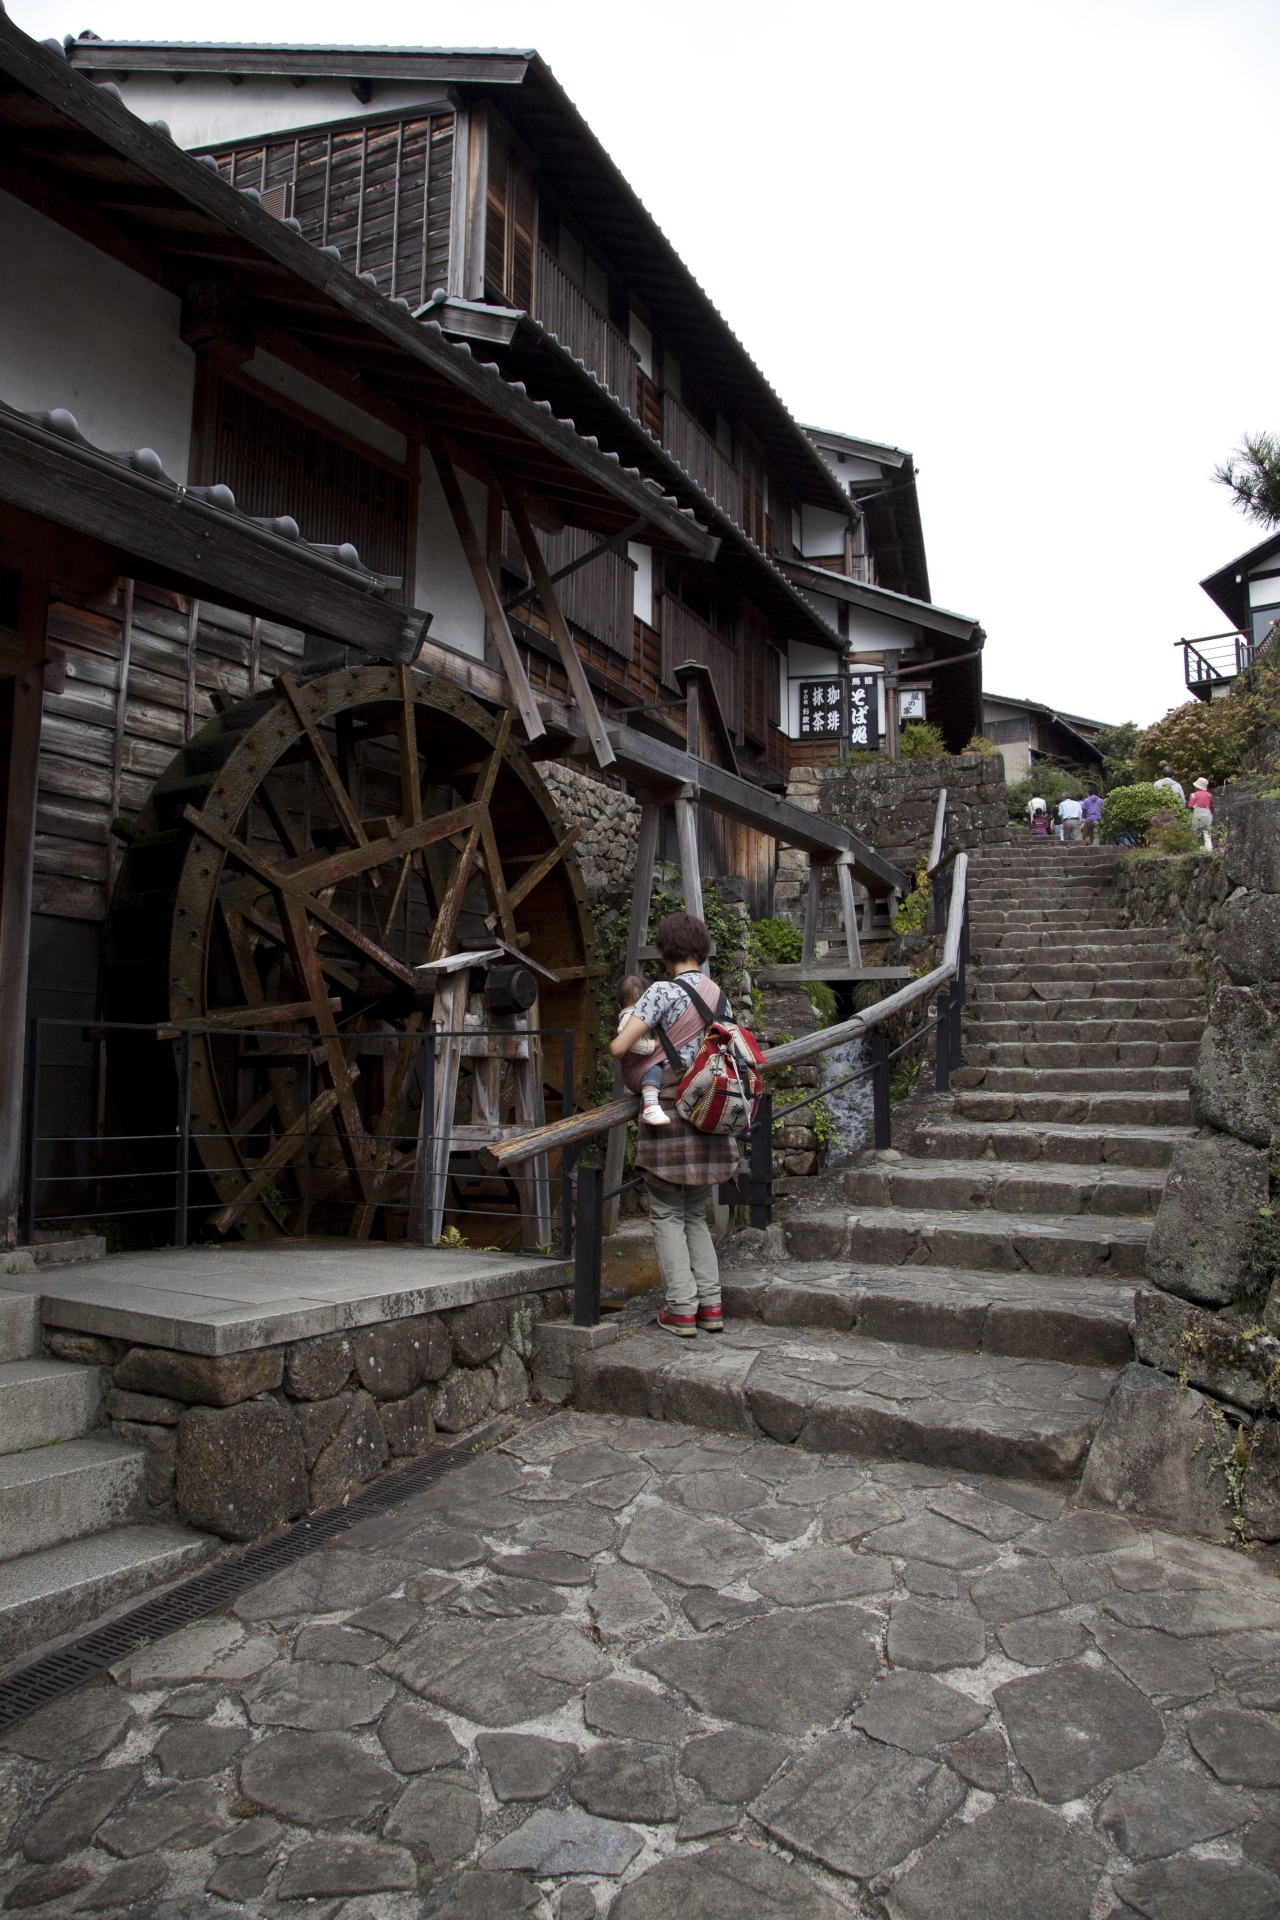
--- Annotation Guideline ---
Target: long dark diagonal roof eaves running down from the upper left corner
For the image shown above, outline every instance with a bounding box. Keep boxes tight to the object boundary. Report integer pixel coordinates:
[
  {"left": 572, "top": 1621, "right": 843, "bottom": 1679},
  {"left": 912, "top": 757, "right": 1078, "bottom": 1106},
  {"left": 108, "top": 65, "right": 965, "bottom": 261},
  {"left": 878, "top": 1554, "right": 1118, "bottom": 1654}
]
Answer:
[{"left": 0, "top": 26, "right": 718, "bottom": 559}]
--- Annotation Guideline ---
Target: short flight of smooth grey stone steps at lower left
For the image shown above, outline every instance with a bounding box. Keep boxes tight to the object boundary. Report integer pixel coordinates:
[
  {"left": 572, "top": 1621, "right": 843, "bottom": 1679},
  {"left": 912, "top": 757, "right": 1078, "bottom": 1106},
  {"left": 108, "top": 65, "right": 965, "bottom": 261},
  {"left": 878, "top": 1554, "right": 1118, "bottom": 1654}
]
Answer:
[{"left": 0, "top": 1279, "right": 215, "bottom": 1668}]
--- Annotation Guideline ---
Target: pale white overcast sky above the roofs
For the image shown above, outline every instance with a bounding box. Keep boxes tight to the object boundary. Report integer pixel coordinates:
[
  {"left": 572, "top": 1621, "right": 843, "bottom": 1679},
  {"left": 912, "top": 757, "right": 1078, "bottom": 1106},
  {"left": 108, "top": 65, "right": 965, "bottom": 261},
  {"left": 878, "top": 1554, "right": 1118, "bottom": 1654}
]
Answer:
[{"left": 8, "top": 0, "right": 1280, "bottom": 724}]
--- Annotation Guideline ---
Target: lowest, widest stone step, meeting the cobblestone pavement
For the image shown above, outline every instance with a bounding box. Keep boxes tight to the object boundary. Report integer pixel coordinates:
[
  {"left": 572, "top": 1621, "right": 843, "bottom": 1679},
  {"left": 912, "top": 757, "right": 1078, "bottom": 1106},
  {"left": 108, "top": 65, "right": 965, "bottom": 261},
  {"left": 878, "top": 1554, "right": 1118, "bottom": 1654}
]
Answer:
[{"left": 574, "top": 1321, "right": 1113, "bottom": 1480}]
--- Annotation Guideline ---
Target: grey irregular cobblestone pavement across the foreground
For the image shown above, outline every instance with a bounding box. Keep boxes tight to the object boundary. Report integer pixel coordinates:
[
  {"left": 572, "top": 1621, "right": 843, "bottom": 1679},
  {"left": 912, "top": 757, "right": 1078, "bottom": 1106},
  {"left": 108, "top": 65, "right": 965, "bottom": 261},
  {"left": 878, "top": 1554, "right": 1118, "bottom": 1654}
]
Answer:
[{"left": 0, "top": 1413, "right": 1280, "bottom": 1920}]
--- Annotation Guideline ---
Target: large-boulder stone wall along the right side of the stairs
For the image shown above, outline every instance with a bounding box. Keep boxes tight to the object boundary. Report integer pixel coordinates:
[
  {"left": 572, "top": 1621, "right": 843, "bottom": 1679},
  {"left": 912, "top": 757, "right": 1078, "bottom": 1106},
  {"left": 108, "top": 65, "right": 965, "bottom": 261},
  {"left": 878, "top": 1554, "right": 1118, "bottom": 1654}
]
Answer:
[{"left": 1084, "top": 795, "right": 1280, "bottom": 1544}]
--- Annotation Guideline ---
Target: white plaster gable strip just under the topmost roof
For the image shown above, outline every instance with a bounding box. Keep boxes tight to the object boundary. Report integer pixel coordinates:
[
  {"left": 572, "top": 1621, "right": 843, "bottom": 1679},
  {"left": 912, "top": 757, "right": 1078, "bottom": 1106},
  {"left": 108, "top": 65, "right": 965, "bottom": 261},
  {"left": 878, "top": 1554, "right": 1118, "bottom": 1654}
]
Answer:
[{"left": 117, "top": 73, "right": 447, "bottom": 148}]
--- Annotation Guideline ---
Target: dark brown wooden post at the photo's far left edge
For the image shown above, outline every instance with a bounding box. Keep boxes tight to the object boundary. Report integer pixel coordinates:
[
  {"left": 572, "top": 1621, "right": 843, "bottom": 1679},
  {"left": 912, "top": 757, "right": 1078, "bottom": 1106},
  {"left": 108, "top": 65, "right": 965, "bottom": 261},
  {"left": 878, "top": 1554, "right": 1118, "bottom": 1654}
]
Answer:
[{"left": 0, "top": 572, "right": 48, "bottom": 1246}]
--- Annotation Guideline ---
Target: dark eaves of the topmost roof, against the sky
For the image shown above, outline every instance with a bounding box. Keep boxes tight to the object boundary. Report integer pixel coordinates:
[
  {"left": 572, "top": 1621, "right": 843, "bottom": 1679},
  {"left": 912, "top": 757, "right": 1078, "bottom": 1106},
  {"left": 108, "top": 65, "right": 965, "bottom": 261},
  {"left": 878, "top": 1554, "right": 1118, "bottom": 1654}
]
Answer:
[{"left": 67, "top": 40, "right": 848, "bottom": 526}]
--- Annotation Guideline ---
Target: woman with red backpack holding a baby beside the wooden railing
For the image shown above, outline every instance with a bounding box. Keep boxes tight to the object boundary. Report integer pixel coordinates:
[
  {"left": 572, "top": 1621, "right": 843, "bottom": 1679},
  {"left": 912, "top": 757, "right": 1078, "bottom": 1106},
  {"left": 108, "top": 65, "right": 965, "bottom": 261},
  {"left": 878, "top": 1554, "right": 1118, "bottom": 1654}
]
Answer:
[{"left": 608, "top": 914, "right": 737, "bottom": 1338}]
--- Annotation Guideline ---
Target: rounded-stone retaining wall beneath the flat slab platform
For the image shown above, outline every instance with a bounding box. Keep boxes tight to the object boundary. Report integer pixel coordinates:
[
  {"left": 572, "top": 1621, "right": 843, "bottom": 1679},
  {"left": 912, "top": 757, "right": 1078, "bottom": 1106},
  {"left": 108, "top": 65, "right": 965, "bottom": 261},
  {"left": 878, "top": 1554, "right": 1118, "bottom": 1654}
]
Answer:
[{"left": 48, "top": 1288, "right": 572, "bottom": 1540}]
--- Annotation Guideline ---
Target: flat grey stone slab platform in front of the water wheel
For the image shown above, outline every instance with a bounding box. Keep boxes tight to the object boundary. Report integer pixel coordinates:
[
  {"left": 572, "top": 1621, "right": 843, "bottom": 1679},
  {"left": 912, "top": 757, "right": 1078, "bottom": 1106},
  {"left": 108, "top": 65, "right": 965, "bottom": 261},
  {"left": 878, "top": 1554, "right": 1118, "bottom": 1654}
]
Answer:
[{"left": 0, "top": 1240, "right": 572, "bottom": 1357}]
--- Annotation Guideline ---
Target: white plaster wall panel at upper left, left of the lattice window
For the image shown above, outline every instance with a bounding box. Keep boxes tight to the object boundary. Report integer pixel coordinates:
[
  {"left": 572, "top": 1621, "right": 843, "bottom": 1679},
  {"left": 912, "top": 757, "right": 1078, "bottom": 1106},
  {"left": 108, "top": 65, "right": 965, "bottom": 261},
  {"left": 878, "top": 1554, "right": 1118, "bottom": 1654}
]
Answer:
[{"left": 0, "top": 194, "right": 196, "bottom": 480}]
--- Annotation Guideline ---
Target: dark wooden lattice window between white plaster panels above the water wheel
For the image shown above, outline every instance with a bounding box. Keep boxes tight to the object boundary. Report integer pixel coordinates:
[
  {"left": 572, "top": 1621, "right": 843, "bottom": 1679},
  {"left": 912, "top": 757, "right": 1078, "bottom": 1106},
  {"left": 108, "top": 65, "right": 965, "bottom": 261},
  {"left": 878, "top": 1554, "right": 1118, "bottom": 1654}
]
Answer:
[{"left": 200, "top": 371, "right": 416, "bottom": 599}]
